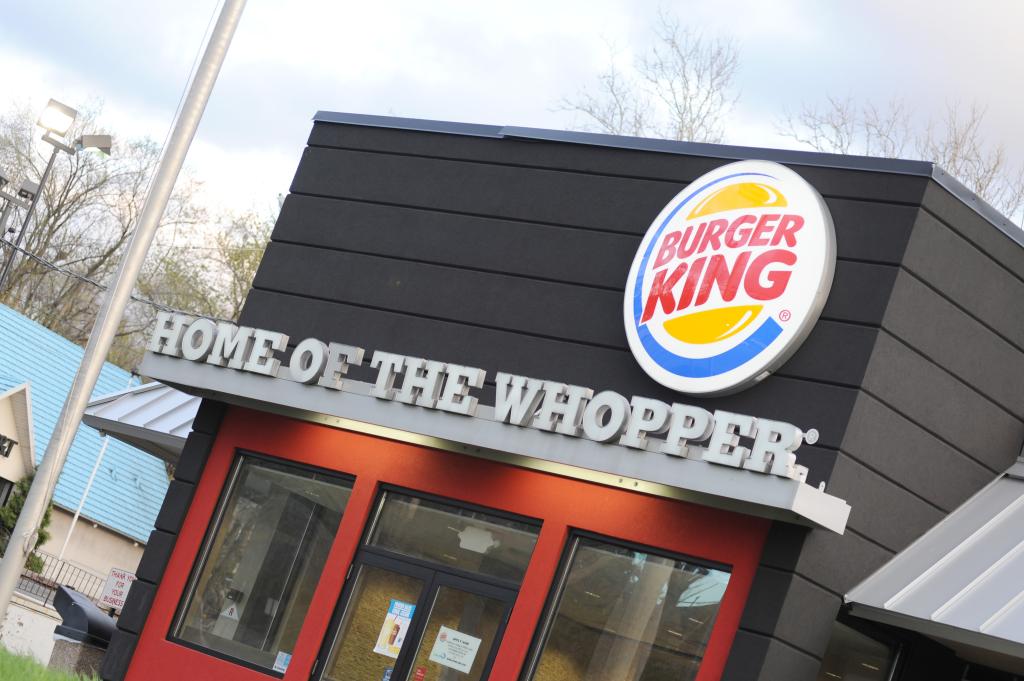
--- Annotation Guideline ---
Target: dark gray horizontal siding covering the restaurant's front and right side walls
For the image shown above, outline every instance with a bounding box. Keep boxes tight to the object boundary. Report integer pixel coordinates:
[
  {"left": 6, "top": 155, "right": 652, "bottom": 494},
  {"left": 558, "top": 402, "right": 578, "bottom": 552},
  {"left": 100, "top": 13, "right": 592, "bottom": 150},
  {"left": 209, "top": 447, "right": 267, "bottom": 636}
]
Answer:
[{"left": 224, "top": 123, "right": 1024, "bottom": 681}]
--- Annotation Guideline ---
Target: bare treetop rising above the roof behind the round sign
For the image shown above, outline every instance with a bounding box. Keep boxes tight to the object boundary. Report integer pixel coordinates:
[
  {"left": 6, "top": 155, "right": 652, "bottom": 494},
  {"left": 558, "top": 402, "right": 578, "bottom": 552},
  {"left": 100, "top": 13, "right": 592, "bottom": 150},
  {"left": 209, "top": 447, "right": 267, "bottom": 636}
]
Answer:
[{"left": 558, "top": 10, "right": 739, "bottom": 142}]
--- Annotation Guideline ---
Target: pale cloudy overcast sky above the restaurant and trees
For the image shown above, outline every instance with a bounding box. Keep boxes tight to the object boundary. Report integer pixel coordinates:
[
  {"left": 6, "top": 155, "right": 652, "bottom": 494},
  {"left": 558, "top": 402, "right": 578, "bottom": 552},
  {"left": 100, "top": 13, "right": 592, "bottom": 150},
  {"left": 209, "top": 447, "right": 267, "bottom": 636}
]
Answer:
[{"left": 0, "top": 0, "right": 1024, "bottom": 218}]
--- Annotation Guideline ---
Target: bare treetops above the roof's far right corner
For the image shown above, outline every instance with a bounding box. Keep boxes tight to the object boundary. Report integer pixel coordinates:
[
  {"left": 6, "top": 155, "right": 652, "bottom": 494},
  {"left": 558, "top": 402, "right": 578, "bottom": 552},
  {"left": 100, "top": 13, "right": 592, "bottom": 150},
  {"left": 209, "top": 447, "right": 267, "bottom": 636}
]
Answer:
[{"left": 777, "top": 97, "right": 1024, "bottom": 222}]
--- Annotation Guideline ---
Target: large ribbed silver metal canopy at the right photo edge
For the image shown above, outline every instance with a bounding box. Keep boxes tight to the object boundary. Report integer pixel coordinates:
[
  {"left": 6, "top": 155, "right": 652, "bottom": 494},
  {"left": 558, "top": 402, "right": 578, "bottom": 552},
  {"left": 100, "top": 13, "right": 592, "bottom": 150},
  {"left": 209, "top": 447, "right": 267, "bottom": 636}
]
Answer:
[{"left": 846, "top": 459, "right": 1024, "bottom": 673}]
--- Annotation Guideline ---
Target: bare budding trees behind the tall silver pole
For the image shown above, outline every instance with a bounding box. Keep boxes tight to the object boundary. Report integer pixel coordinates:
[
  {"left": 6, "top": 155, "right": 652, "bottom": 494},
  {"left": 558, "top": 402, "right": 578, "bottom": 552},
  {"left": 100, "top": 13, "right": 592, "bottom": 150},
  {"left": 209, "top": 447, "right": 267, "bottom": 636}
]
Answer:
[{"left": 0, "top": 105, "right": 271, "bottom": 368}]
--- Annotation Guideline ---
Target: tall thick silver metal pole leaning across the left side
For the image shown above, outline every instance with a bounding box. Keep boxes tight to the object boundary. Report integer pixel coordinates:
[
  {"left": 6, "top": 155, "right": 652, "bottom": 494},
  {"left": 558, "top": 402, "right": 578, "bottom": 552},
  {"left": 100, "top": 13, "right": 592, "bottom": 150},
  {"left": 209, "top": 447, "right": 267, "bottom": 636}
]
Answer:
[{"left": 0, "top": 0, "right": 246, "bottom": 622}]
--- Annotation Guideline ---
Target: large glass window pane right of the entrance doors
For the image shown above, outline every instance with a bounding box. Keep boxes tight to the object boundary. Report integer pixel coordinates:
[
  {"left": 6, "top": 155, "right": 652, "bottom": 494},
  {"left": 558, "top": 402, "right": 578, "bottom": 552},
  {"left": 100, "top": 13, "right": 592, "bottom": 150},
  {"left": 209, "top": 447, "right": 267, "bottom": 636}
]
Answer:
[{"left": 534, "top": 539, "right": 729, "bottom": 681}]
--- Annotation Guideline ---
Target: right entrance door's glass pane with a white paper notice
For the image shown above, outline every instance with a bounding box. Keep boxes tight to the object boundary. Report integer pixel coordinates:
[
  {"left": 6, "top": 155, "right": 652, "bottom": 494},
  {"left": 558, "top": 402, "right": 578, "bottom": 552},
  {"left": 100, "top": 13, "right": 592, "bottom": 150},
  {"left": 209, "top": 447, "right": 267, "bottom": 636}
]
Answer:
[{"left": 408, "top": 587, "right": 508, "bottom": 681}]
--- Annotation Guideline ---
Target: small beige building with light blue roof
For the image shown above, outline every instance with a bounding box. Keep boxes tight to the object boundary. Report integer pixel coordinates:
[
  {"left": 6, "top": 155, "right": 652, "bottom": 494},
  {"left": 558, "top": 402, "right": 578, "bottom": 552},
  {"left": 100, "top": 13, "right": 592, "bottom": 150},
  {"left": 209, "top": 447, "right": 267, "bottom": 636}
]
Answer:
[{"left": 0, "top": 305, "right": 169, "bottom": 574}]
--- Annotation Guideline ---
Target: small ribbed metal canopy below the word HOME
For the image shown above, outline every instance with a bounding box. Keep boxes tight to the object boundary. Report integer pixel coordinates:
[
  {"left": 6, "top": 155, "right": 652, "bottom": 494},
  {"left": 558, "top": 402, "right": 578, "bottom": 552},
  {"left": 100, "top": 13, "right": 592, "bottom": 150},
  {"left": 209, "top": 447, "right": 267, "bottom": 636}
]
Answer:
[{"left": 82, "top": 383, "right": 200, "bottom": 464}]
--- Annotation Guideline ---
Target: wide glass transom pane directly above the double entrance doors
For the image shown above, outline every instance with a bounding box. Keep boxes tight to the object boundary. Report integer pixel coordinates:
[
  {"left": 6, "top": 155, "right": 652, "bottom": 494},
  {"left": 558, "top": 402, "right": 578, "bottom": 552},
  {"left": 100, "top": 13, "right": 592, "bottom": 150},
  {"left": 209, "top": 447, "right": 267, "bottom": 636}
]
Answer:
[{"left": 369, "top": 493, "right": 538, "bottom": 583}]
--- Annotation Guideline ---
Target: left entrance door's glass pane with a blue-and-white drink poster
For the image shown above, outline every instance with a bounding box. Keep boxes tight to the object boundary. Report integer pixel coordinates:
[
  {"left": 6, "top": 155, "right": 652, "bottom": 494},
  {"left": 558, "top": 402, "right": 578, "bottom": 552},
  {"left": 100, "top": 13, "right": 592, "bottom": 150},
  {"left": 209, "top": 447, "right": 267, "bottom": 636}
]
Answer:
[{"left": 322, "top": 565, "right": 424, "bottom": 681}]
